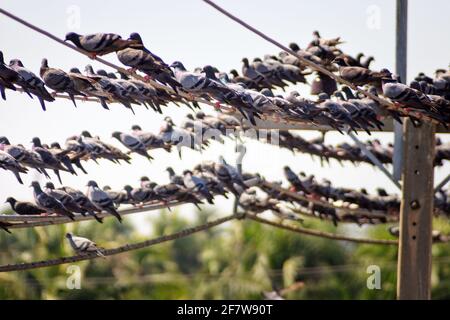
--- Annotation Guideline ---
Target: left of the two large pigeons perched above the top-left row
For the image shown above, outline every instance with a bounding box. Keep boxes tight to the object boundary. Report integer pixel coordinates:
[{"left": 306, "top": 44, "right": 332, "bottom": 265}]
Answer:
[{"left": 64, "top": 32, "right": 139, "bottom": 58}]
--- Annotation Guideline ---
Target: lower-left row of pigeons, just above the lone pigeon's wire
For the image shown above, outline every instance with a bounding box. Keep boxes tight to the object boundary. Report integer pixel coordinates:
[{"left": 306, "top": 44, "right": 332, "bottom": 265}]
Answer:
[{"left": 0, "top": 157, "right": 260, "bottom": 232}]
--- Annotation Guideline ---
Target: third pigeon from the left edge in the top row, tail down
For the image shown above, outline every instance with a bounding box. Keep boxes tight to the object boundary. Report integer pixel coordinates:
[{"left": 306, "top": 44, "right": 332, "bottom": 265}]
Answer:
[{"left": 40, "top": 58, "right": 86, "bottom": 107}]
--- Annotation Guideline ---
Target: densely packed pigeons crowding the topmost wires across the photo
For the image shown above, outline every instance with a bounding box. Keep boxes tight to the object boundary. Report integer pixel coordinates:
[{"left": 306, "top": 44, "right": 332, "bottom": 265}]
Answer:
[{"left": 0, "top": 32, "right": 450, "bottom": 129}]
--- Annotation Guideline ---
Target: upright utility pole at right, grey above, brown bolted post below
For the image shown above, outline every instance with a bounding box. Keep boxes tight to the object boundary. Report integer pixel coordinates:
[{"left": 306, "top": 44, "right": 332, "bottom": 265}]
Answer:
[{"left": 395, "top": 0, "right": 435, "bottom": 300}]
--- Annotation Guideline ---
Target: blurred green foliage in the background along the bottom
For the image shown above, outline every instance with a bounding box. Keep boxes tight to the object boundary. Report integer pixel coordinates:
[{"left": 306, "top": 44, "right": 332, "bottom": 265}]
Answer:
[{"left": 0, "top": 209, "right": 450, "bottom": 299}]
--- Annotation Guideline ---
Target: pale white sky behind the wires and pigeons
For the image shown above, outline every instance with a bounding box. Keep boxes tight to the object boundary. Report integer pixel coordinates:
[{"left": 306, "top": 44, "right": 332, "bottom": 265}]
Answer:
[{"left": 0, "top": 0, "right": 450, "bottom": 232}]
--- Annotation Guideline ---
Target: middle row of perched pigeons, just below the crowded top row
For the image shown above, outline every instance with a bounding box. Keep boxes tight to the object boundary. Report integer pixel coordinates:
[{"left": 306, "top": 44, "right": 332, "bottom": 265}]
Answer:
[{"left": 0, "top": 111, "right": 450, "bottom": 183}]
